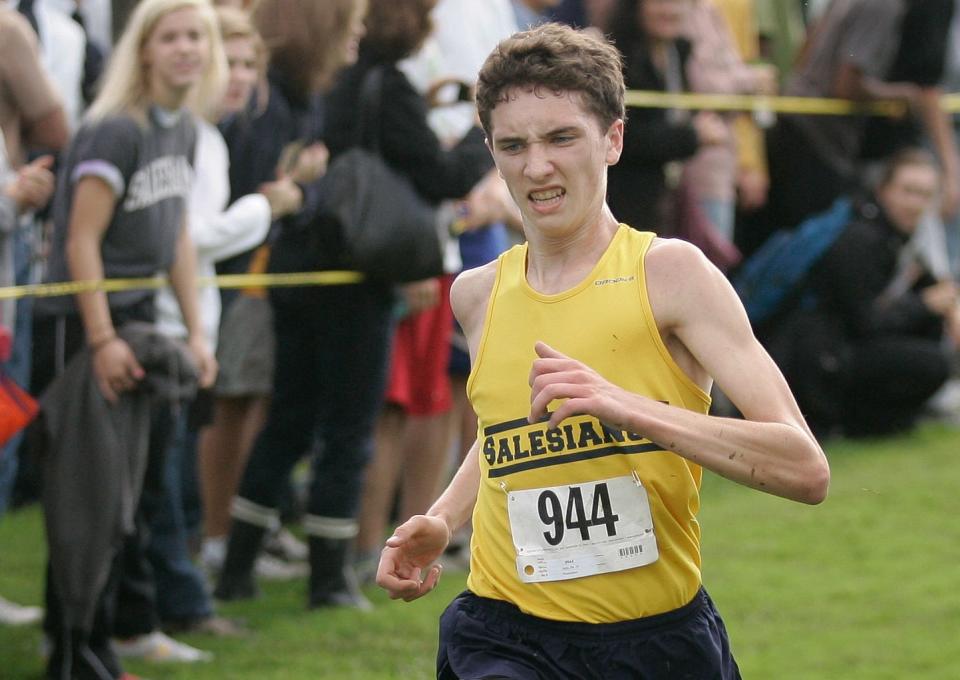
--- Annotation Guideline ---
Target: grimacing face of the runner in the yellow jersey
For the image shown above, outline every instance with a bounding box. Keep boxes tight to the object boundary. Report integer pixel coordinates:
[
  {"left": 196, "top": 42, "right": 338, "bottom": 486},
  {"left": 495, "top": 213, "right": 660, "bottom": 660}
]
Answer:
[{"left": 488, "top": 88, "right": 623, "bottom": 236}]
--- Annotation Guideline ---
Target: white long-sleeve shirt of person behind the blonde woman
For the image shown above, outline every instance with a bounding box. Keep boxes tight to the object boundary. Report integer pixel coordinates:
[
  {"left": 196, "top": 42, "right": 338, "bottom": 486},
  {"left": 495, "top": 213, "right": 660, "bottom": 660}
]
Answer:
[{"left": 157, "top": 121, "right": 270, "bottom": 348}]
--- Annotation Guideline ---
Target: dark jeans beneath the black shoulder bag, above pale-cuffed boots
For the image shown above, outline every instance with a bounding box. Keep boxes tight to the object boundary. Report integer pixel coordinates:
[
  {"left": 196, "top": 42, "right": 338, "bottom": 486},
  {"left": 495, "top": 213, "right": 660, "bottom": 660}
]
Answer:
[{"left": 240, "top": 283, "right": 392, "bottom": 519}]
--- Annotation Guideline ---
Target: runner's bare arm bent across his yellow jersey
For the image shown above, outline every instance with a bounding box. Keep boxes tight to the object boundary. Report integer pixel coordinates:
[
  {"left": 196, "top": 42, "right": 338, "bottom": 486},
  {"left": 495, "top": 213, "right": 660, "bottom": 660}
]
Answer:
[{"left": 530, "top": 239, "right": 830, "bottom": 503}]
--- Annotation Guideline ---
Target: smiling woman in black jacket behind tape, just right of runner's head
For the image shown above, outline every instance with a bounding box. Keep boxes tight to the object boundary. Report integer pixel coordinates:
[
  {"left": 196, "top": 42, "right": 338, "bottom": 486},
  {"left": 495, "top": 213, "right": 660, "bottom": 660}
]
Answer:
[{"left": 608, "top": 0, "right": 728, "bottom": 234}]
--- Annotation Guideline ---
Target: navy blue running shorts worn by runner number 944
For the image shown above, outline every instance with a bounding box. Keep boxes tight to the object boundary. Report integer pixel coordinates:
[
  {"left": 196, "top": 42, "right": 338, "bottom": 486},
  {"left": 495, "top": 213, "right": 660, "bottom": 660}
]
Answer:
[{"left": 437, "top": 588, "right": 740, "bottom": 680}]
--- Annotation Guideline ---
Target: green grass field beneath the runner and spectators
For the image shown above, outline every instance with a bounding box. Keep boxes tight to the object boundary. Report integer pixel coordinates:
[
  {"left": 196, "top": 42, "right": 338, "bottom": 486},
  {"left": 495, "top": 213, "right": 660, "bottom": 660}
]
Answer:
[{"left": 0, "top": 425, "right": 960, "bottom": 680}]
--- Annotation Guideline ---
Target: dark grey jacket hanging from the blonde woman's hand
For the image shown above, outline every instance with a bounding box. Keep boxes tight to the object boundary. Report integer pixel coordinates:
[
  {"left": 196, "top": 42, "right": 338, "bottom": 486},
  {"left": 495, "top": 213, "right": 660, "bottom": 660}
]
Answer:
[{"left": 40, "top": 322, "right": 197, "bottom": 632}]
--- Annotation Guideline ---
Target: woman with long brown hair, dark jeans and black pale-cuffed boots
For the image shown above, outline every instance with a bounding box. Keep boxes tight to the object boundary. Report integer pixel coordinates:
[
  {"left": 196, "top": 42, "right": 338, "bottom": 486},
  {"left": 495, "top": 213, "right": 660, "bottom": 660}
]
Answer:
[{"left": 214, "top": 0, "right": 391, "bottom": 606}]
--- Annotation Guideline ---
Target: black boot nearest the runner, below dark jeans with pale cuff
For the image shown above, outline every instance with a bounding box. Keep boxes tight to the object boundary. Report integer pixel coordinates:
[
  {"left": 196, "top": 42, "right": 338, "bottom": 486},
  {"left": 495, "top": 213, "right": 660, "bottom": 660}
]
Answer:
[{"left": 307, "top": 536, "right": 373, "bottom": 611}]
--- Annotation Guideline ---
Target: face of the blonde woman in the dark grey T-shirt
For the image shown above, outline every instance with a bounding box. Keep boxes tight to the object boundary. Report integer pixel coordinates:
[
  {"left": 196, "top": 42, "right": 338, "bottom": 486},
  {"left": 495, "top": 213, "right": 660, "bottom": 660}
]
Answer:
[{"left": 142, "top": 7, "right": 210, "bottom": 108}]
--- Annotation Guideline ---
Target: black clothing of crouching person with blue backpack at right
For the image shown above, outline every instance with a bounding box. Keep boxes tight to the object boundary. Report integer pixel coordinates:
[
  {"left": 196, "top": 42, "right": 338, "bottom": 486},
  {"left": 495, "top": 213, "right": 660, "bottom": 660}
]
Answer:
[{"left": 762, "top": 194, "right": 947, "bottom": 432}]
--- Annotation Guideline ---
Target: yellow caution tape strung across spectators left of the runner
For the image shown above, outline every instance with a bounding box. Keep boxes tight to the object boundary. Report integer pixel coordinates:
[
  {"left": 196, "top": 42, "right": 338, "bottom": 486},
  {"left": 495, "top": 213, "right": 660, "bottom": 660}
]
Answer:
[{"left": 0, "top": 271, "right": 365, "bottom": 300}]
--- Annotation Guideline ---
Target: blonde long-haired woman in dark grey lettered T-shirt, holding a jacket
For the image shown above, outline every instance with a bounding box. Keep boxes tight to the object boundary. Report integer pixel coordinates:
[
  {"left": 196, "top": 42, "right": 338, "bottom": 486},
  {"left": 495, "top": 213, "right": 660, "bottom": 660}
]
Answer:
[{"left": 36, "top": 0, "right": 226, "bottom": 680}]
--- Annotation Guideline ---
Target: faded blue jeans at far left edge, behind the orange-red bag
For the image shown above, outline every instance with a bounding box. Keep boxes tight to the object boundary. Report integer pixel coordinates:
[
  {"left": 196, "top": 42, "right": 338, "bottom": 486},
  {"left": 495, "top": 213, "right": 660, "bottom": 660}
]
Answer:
[{"left": 0, "top": 229, "right": 33, "bottom": 516}]
